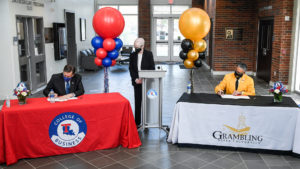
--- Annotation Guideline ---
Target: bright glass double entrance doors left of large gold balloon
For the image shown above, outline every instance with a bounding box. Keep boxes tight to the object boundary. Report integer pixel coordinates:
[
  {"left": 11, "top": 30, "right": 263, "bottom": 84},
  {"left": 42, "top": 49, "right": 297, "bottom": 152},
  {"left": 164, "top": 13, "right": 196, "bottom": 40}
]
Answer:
[{"left": 152, "top": 17, "right": 184, "bottom": 61}]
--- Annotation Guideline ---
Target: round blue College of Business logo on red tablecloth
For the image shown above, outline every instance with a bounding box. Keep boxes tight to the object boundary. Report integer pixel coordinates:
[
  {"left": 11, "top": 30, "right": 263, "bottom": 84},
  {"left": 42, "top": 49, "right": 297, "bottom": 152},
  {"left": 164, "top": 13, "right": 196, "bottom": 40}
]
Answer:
[{"left": 49, "top": 112, "right": 87, "bottom": 148}]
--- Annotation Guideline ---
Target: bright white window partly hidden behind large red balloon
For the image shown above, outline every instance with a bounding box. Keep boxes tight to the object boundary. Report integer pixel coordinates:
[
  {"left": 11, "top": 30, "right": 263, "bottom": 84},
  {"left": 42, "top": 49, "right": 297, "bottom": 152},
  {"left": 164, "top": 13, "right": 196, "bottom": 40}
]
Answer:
[{"left": 99, "top": 5, "right": 138, "bottom": 46}]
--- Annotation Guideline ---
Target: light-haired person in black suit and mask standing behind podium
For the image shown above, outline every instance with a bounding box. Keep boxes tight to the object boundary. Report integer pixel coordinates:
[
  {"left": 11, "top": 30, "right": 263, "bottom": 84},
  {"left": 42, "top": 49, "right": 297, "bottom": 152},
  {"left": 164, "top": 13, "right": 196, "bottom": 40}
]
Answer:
[{"left": 129, "top": 38, "right": 155, "bottom": 127}]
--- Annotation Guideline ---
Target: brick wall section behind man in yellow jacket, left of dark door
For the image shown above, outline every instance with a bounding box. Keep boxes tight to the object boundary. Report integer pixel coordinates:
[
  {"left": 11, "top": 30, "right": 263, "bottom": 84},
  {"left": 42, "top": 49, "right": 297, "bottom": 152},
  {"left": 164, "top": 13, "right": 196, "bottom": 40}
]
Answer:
[{"left": 213, "top": 0, "right": 257, "bottom": 71}]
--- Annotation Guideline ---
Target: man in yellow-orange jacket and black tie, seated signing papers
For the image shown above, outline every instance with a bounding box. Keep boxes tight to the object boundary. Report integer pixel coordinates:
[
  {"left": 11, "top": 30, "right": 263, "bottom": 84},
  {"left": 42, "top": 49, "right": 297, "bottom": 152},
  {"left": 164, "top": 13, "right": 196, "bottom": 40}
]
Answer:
[{"left": 215, "top": 63, "right": 255, "bottom": 96}]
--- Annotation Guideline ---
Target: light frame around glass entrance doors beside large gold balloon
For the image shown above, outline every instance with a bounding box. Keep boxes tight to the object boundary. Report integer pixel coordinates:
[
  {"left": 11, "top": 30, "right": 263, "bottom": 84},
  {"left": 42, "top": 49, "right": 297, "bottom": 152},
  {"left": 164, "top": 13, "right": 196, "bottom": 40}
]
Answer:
[{"left": 151, "top": 14, "right": 181, "bottom": 61}]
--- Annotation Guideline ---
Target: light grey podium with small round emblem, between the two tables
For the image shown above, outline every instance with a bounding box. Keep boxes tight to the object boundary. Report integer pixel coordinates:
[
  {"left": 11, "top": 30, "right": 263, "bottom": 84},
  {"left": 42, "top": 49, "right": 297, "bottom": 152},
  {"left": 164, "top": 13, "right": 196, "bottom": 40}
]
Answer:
[{"left": 139, "top": 66, "right": 169, "bottom": 134}]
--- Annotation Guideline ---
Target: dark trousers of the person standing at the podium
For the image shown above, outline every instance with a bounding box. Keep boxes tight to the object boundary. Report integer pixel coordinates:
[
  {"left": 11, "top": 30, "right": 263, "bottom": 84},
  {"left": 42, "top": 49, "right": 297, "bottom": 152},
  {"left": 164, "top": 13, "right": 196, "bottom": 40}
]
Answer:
[{"left": 133, "top": 84, "right": 142, "bottom": 125}]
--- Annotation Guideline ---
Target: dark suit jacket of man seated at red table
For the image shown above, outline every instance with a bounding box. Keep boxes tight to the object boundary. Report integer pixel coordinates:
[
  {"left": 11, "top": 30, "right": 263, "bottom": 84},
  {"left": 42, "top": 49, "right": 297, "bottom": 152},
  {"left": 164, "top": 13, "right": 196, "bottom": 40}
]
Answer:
[{"left": 43, "top": 73, "right": 84, "bottom": 97}]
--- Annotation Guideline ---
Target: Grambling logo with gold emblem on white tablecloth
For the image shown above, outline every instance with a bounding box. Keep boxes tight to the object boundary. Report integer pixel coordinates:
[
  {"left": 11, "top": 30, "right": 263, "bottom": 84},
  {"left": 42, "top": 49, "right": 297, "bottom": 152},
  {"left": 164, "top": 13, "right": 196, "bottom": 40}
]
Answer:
[{"left": 212, "top": 114, "right": 263, "bottom": 144}]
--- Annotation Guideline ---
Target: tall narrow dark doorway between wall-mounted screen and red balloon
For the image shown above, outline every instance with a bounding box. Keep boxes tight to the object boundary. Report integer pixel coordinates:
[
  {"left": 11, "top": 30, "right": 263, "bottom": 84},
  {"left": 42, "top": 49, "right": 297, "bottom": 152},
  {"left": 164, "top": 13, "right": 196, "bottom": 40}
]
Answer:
[{"left": 65, "top": 10, "right": 78, "bottom": 67}]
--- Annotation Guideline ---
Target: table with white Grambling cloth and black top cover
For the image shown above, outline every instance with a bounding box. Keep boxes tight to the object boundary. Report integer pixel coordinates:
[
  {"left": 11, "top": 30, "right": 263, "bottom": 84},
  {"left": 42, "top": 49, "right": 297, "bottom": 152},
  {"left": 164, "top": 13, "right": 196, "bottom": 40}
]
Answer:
[{"left": 168, "top": 93, "right": 300, "bottom": 153}]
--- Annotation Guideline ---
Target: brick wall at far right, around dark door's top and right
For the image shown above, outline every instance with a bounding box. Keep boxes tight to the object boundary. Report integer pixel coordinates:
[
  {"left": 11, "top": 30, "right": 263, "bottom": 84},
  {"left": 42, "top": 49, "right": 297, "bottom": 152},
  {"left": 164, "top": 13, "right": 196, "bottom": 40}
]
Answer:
[{"left": 257, "top": 0, "right": 294, "bottom": 84}]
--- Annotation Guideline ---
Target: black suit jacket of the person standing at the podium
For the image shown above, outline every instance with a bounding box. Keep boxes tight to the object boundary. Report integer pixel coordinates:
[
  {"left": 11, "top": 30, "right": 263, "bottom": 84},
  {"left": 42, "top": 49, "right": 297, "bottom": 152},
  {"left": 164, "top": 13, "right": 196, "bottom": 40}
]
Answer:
[{"left": 129, "top": 50, "right": 155, "bottom": 85}]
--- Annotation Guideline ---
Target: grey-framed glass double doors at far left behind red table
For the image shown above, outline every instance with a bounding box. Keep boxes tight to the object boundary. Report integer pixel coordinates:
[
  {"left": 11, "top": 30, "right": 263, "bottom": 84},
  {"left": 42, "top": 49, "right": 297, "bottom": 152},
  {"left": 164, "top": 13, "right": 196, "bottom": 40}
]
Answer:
[{"left": 16, "top": 16, "right": 47, "bottom": 93}]
